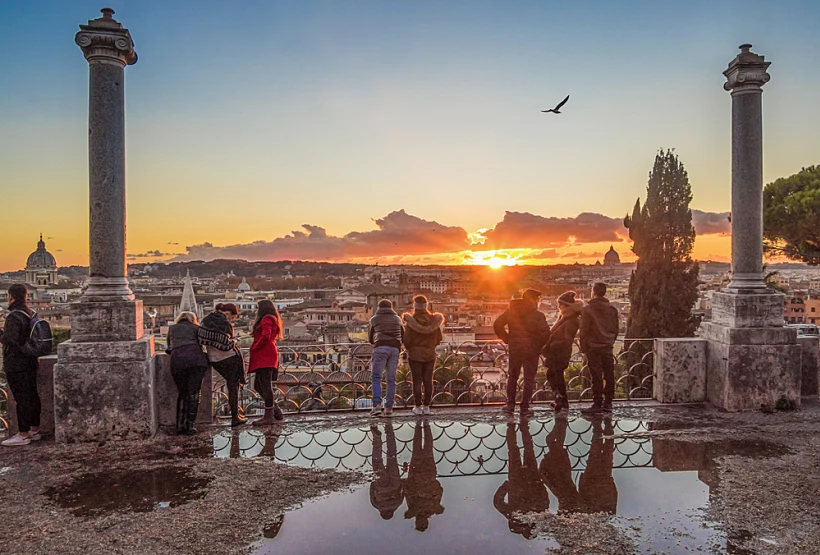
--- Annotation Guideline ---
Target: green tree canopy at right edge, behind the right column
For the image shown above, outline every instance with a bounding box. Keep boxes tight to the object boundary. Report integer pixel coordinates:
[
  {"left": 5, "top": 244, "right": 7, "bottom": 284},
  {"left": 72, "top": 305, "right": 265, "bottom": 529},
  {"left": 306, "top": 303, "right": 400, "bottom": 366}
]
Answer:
[{"left": 763, "top": 166, "right": 820, "bottom": 266}]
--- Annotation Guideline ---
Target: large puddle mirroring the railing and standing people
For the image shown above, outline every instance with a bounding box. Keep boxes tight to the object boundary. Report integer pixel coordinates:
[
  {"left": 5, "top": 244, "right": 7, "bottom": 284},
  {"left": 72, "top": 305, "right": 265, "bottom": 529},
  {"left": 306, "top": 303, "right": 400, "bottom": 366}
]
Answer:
[{"left": 226, "top": 418, "right": 783, "bottom": 555}]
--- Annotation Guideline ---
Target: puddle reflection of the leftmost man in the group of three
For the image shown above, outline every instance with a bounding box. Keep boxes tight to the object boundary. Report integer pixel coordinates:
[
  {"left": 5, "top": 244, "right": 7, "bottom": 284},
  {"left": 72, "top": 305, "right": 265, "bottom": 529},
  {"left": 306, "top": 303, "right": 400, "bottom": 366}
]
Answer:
[{"left": 493, "top": 422, "right": 550, "bottom": 539}]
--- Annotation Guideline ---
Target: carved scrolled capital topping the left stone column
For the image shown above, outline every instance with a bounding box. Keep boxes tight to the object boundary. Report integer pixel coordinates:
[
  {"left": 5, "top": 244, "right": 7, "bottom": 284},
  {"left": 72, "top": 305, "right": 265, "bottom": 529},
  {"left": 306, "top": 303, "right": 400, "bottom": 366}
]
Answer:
[{"left": 74, "top": 8, "right": 137, "bottom": 67}]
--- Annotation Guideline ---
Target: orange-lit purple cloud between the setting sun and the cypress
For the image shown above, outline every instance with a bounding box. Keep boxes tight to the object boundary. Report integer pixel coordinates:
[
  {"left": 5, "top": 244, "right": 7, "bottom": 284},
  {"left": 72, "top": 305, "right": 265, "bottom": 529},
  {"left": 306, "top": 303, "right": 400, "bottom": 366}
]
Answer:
[{"left": 483, "top": 212, "right": 627, "bottom": 249}]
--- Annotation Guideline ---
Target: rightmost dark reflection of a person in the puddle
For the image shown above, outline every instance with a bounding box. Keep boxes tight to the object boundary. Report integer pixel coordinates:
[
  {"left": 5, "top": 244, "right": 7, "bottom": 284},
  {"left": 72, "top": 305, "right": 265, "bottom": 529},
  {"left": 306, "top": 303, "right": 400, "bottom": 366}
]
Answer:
[{"left": 578, "top": 418, "right": 618, "bottom": 515}]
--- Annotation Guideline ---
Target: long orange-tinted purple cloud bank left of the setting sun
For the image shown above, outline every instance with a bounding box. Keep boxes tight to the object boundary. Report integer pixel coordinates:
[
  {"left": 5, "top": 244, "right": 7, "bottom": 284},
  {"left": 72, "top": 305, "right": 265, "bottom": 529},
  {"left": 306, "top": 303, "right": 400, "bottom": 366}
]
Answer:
[{"left": 175, "top": 210, "right": 470, "bottom": 261}]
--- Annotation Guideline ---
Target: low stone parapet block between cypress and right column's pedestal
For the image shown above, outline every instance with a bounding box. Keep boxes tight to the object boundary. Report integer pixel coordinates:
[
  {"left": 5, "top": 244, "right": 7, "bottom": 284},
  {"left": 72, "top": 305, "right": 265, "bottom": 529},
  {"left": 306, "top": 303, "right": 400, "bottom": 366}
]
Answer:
[{"left": 653, "top": 338, "right": 708, "bottom": 403}]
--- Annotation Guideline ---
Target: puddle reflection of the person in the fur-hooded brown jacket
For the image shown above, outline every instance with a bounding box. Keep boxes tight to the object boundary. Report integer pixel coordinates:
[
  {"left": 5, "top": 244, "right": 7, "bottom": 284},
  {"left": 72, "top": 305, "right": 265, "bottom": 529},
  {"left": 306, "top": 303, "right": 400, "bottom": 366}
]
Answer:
[{"left": 404, "top": 421, "right": 444, "bottom": 532}]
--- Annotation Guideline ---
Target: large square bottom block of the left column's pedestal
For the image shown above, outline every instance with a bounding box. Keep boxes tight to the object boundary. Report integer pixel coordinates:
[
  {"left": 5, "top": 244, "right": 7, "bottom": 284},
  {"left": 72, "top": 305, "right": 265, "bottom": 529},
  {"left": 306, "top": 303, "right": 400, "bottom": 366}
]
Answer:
[{"left": 54, "top": 336, "right": 157, "bottom": 443}]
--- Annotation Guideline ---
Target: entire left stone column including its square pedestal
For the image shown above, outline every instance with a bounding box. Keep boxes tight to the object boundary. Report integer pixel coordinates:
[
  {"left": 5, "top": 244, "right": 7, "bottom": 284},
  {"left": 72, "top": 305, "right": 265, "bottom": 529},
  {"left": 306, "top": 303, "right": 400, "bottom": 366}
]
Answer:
[{"left": 54, "top": 8, "right": 157, "bottom": 442}]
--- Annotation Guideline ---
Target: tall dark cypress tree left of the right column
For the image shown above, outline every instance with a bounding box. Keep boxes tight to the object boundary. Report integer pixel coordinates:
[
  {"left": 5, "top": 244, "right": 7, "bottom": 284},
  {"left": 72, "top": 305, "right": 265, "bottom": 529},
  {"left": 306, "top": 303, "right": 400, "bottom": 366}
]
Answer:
[{"left": 624, "top": 150, "right": 700, "bottom": 338}]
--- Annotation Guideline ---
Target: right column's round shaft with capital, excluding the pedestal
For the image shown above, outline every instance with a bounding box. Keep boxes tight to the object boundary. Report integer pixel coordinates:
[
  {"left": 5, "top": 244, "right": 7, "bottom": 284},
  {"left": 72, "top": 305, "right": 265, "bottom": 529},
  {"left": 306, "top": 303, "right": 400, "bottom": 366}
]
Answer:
[{"left": 723, "top": 44, "right": 771, "bottom": 292}]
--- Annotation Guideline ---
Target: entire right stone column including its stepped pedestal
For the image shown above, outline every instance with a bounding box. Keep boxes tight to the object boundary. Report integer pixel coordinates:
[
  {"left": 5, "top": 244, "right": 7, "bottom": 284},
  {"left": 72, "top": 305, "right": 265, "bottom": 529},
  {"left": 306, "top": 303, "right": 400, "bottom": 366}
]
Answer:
[{"left": 700, "top": 44, "right": 802, "bottom": 411}]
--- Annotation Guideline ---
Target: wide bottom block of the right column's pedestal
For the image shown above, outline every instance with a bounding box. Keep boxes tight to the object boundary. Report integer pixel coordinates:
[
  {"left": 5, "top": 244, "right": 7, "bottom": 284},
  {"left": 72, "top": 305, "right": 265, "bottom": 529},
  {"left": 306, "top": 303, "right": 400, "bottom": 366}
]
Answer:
[{"left": 700, "top": 322, "right": 802, "bottom": 412}]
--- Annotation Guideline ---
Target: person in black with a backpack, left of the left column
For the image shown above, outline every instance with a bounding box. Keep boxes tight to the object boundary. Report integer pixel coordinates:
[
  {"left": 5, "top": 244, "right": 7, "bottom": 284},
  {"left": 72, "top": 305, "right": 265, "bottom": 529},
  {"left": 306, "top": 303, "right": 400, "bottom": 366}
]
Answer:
[{"left": 0, "top": 283, "right": 41, "bottom": 447}]
